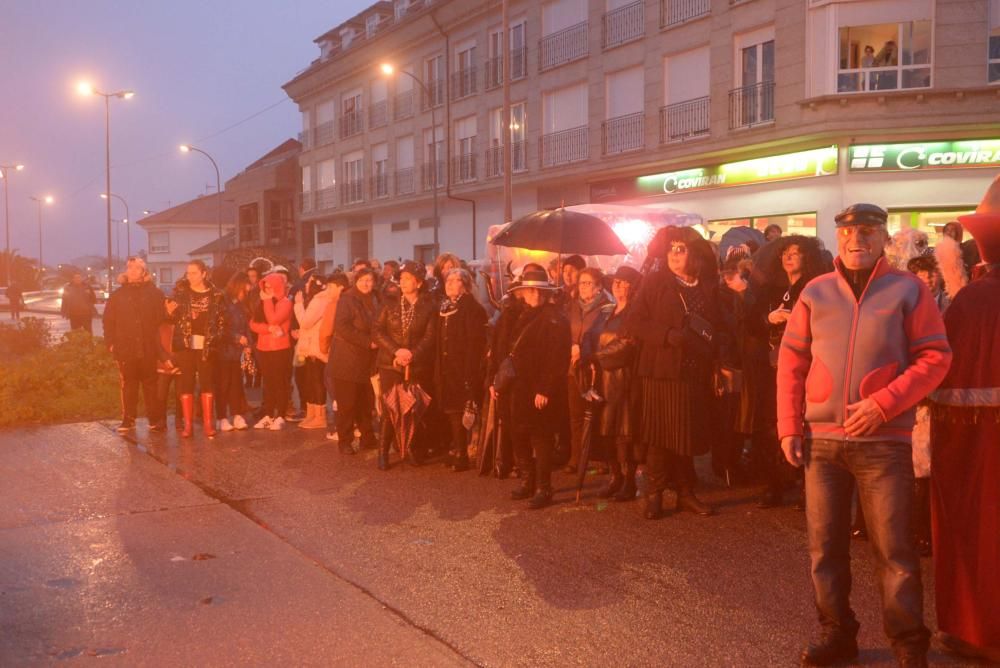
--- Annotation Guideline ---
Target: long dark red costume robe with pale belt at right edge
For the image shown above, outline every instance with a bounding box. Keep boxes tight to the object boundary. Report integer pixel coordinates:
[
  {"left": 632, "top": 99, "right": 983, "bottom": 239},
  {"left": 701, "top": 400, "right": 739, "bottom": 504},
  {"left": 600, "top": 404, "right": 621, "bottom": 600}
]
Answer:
[{"left": 931, "top": 265, "right": 1000, "bottom": 650}]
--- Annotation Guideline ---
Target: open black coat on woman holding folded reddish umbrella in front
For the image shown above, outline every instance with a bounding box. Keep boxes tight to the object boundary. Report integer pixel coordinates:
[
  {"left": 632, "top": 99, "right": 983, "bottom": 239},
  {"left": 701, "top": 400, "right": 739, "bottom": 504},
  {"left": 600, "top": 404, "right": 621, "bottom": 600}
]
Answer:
[{"left": 374, "top": 293, "right": 437, "bottom": 383}]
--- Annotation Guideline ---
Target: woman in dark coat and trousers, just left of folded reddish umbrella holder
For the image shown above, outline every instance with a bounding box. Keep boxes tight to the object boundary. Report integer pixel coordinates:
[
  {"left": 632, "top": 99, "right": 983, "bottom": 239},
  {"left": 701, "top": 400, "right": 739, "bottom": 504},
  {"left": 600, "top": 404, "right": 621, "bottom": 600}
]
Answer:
[{"left": 327, "top": 269, "right": 377, "bottom": 454}]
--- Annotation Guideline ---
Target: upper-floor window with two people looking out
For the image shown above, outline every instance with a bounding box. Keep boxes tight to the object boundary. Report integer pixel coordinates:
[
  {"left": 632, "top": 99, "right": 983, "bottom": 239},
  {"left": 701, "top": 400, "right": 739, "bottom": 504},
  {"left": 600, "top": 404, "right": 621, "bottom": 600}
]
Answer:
[{"left": 837, "top": 21, "right": 932, "bottom": 93}]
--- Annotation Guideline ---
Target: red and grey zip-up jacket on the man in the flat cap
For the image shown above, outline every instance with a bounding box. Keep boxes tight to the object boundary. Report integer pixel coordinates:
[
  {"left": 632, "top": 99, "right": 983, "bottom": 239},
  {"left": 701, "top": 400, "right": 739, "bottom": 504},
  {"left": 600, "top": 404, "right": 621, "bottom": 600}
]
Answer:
[{"left": 777, "top": 258, "right": 951, "bottom": 443}]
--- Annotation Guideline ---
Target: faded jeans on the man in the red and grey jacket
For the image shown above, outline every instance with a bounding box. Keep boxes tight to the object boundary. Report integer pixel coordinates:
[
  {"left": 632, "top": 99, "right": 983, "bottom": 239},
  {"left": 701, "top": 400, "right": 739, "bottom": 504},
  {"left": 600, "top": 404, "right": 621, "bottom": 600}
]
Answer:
[{"left": 804, "top": 440, "right": 930, "bottom": 651}]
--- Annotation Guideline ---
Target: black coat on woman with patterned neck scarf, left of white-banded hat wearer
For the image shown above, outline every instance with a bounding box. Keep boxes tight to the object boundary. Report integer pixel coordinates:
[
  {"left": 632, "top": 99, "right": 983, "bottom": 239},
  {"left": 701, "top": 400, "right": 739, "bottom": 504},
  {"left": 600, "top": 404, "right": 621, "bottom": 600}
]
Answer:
[{"left": 434, "top": 294, "right": 487, "bottom": 412}]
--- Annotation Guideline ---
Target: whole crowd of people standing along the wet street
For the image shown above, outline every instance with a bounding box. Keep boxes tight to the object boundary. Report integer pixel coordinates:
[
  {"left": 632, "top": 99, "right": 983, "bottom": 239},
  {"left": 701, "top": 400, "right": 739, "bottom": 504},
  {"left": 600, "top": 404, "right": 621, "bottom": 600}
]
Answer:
[{"left": 97, "top": 180, "right": 1000, "bottom": 665}]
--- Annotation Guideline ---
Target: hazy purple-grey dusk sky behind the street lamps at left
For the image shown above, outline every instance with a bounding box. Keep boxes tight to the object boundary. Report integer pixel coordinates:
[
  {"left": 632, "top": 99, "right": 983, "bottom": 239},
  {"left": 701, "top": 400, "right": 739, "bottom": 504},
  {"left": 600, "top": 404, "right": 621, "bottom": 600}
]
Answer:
[{"left": 0, "top": 0, "right": 370, "bottom": 264}]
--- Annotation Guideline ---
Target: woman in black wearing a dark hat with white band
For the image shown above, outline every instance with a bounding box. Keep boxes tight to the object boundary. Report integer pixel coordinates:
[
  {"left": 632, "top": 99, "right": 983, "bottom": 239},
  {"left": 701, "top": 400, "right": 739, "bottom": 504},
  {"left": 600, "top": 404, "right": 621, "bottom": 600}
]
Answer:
[{"left": 491, "top": 269, "right": 570, "bottom": 508}]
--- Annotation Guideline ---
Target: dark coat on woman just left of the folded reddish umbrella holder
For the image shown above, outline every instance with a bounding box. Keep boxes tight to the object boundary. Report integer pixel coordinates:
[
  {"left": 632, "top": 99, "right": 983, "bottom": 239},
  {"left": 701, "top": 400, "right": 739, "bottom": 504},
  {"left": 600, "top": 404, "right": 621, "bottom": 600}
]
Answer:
[{"left": 327, "top": 288, "right": 376, "bottom": 383}]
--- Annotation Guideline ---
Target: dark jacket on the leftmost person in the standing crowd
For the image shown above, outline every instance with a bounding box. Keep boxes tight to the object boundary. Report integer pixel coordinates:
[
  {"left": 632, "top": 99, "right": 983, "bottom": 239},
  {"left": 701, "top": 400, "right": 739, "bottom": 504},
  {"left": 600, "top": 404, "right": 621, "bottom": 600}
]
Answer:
[{"left": 103, "top": 281, "right": 167, "bottom": 362}]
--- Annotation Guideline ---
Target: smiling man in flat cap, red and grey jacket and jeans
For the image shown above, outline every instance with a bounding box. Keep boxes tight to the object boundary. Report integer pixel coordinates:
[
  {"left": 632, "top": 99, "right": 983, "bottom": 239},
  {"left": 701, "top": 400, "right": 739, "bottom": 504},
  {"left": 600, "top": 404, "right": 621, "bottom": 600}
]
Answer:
[{"left": 778, "top": 204, "right": 951, "bottom": 666}]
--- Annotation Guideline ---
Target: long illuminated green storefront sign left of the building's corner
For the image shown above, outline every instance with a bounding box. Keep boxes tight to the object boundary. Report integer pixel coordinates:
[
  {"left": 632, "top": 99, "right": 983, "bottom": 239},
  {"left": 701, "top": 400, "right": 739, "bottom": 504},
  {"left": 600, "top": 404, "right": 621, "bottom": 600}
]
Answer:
[{"left": 590, "top": 146, "right": 837, "bottom": 202}]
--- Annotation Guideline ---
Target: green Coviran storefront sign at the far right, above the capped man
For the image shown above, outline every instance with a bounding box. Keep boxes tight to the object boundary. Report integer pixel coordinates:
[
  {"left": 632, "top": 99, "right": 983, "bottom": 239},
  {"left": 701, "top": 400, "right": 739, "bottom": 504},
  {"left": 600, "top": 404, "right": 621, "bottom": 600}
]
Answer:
[{"left": 848, "top": 139, "right": 1000, "bottom": 172}]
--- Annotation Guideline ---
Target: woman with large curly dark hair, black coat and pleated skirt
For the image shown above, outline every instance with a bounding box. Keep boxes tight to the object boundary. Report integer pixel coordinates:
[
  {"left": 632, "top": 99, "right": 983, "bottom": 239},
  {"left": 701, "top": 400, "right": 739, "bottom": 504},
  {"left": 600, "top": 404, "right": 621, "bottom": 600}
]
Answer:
[{"left": 626, "top": 226, "right": 724, "bottom": 519}]
